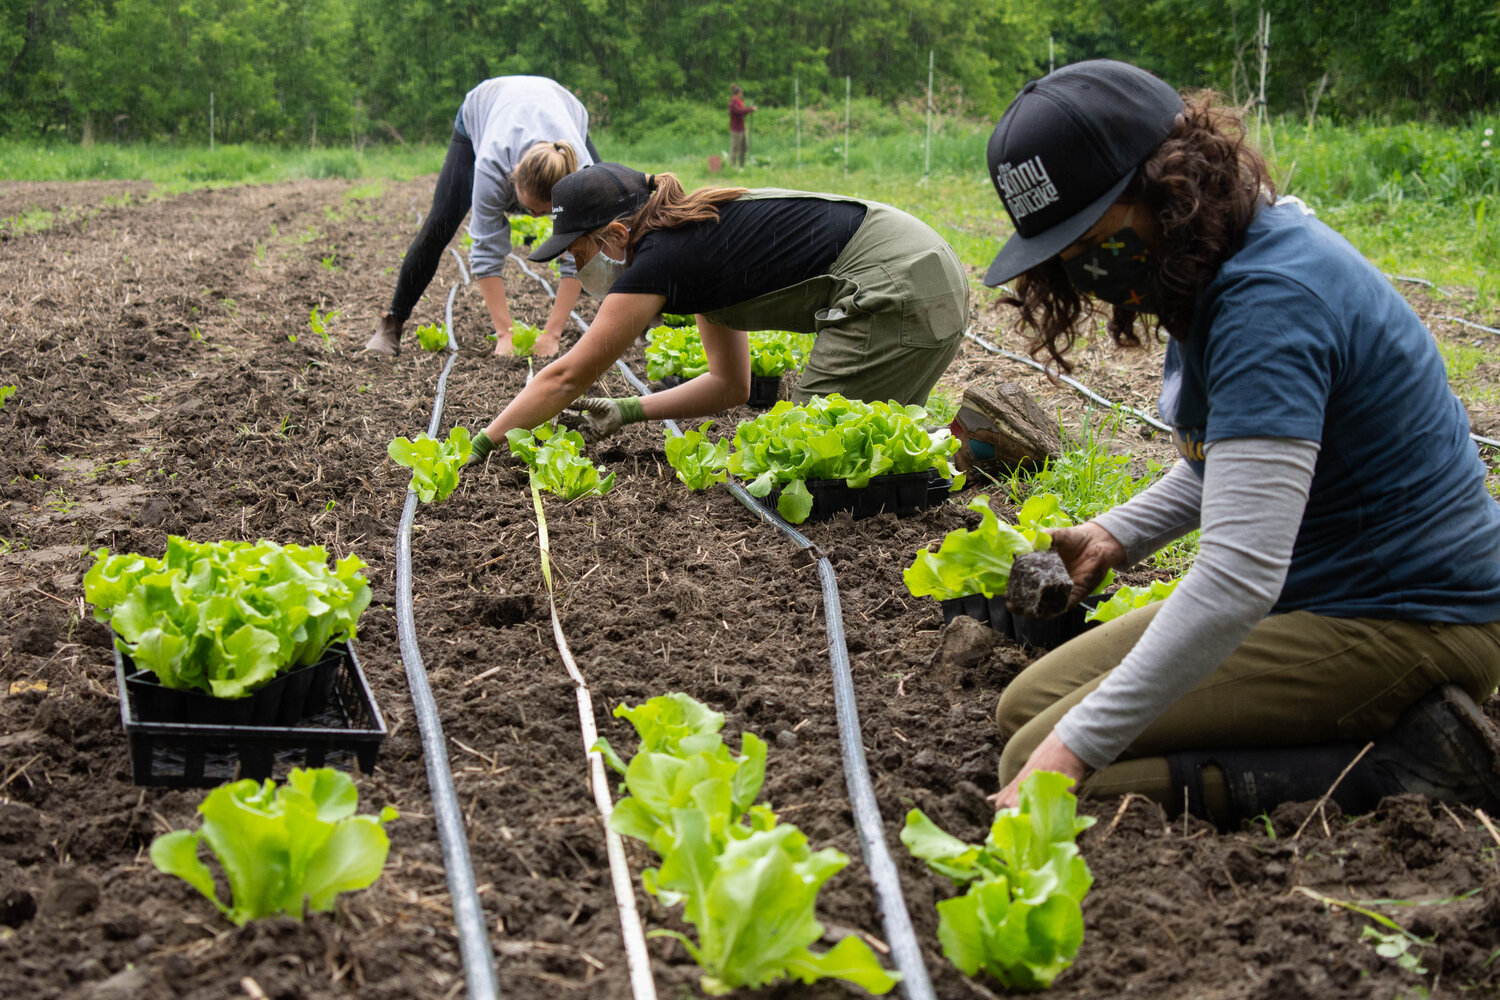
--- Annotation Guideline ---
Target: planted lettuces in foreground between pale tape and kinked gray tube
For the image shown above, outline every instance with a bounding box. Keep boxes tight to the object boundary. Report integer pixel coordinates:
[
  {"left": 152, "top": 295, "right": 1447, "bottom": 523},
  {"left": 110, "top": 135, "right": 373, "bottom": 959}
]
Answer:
[{"left": 594, "top": 694, "right": 900, "bottom": 996}]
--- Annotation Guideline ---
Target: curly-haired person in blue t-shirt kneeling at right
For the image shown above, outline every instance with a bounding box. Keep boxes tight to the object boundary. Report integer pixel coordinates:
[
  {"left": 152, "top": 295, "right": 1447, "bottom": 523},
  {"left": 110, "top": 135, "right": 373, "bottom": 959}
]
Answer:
[{"left": 986, "top": 60, "right": 1500, "bottom": 826}]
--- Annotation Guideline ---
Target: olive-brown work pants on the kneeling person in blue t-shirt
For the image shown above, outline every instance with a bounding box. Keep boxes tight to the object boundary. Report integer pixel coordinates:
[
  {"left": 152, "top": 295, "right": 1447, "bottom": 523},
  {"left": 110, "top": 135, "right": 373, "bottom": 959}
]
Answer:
[{"left": 995, "top": 604, "right": 1500, "bottom": 814}]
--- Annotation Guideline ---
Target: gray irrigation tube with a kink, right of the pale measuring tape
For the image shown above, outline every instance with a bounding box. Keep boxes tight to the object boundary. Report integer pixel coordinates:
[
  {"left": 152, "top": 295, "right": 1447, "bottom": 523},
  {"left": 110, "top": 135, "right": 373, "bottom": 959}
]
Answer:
[{"left": 504, "top": 258, "right": 938, "bottom": 1000}]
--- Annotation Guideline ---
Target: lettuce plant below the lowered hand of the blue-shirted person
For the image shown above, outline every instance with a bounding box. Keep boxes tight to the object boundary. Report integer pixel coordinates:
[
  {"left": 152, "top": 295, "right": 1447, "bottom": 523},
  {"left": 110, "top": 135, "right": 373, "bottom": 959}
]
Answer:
[{"left": 902, "top": 771, "right": 1094, "bottom": 990}]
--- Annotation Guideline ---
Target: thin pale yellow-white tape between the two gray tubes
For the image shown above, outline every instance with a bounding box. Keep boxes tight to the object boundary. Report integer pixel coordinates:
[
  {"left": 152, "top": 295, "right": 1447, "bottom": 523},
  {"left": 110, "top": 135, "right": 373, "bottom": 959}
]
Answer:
[{"left": 531, "top": 478, "right": 657, "bottom": 1000}]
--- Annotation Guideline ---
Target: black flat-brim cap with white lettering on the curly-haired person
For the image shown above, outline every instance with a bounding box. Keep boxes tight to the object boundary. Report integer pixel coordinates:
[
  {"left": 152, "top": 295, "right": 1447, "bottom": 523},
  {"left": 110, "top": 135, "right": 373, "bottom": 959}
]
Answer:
[{"left": 984, "top": 58, "right": 1184, "bottom": 286}]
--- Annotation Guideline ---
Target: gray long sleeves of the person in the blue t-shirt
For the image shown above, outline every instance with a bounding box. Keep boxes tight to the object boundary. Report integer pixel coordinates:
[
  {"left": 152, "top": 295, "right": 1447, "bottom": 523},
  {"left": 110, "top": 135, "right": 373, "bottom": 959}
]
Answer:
[{"left": 1056, "top": 438, "right": 1319, "bottom": 769}]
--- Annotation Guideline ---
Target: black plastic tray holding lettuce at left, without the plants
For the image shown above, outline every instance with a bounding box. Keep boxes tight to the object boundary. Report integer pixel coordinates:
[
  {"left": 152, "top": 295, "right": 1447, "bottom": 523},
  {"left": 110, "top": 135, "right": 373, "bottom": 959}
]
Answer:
[{"left": 114, "top": 643, "right": 386, "bottom": 789}]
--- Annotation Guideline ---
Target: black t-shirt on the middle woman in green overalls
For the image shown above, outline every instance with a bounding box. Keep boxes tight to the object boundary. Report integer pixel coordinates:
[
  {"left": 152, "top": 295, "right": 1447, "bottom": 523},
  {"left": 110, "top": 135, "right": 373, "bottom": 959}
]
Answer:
[{"left": 609, "top": 198, "right": 866, "bottom": 313}]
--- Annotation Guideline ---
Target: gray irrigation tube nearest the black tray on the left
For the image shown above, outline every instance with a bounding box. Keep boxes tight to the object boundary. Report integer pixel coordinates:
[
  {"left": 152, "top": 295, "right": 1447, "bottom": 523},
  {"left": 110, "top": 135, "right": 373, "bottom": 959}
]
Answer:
[{"left": 396, "top": 256, "right": 500, "bottom": 1000}]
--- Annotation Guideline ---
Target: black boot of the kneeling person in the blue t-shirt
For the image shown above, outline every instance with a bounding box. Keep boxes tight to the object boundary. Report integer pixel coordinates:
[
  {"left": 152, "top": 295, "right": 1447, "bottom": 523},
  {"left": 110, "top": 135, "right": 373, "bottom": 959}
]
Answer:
[{"left": 1167, "top": 684, "right": 1500, "bottom": 829}]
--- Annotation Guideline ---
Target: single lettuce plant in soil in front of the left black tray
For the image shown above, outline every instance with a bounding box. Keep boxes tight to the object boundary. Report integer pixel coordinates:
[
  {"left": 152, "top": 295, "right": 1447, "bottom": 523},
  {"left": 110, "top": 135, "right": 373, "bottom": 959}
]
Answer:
[{"left": 152, "top": 768, "right": 398, "bottom": 927}]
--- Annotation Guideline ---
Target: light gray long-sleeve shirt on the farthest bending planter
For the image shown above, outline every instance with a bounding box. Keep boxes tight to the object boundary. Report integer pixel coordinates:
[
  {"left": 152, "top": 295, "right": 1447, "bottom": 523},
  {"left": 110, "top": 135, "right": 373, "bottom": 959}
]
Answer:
[{"left": 459, "top": 76, "right": 594, "bottom": 277}]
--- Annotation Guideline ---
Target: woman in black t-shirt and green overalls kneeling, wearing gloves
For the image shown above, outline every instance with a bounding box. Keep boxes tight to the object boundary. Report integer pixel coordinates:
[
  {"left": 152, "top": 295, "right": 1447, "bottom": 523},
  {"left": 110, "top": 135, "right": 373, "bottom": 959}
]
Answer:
[{"left": 471, "top": 163, "right": 969, "bottom": 462}]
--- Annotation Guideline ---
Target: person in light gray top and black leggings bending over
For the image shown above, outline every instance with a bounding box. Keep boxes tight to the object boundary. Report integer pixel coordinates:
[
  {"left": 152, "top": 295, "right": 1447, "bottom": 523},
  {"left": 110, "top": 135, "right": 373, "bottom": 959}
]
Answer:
[{"left": 365, "top": 76, "right": 599, "bottom": 357}]
